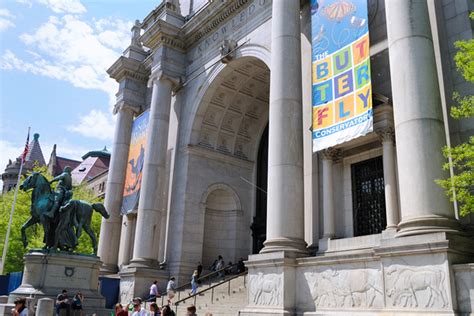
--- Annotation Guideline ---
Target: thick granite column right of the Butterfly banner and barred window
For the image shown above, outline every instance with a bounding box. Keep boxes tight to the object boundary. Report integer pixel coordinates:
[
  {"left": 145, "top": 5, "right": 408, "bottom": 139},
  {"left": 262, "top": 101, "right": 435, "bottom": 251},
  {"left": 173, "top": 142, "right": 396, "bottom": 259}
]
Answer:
[{"left": 385, "top": 0, "right": 457, "bottom": 236}]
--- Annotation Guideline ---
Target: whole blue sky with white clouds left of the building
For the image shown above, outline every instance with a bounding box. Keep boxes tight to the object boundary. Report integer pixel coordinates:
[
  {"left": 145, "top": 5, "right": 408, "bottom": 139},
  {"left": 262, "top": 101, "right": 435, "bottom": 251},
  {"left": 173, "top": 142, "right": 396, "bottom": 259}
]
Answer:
[{"left": 0, "top": 0, "right": 161, "bottom": 178}]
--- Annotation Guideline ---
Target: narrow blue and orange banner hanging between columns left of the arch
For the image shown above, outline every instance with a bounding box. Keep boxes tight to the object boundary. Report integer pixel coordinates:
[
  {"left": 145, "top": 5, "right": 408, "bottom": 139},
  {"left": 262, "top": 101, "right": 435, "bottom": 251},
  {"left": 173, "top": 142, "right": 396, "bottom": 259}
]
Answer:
[{"left": 121, "top": 111, "right": 150, "bottom": 214}]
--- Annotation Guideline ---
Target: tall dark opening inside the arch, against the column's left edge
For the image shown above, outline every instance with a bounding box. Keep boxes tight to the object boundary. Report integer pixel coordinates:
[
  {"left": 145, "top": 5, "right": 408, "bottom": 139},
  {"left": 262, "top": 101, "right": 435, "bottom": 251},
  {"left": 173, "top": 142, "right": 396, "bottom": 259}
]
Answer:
[{"left": 250, "top": 124, "right": 268, "bottom": 254}]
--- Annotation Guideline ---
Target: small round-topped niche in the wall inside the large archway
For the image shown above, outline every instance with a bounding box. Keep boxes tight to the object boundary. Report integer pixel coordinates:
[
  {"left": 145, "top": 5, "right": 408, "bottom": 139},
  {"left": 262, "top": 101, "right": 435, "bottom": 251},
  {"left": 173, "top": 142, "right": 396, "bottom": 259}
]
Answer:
[{"left": 201, "top": 183, "right": 243, "bottom": 268}]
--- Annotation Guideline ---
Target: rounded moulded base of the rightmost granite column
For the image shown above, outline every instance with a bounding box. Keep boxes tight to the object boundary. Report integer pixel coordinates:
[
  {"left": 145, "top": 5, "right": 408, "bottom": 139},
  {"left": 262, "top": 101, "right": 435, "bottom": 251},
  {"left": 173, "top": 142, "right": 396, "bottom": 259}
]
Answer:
[{"left": 396, "top": 215, "right": 462, "bottom": 237}]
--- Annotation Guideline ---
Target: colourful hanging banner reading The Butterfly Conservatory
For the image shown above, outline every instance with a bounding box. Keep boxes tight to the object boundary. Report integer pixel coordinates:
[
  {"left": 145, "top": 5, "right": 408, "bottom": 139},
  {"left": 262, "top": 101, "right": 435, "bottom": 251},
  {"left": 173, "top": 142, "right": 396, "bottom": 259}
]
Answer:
[{"left": 311, "top": 0, "right": 373, "bottom": 152}]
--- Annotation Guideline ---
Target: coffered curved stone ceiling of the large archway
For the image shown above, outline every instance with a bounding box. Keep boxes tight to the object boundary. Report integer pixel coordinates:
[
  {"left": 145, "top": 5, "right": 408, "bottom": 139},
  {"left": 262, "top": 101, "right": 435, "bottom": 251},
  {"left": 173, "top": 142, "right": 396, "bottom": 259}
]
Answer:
[{"left": 197, "top": 60, "right": 270, "bottom": 159}]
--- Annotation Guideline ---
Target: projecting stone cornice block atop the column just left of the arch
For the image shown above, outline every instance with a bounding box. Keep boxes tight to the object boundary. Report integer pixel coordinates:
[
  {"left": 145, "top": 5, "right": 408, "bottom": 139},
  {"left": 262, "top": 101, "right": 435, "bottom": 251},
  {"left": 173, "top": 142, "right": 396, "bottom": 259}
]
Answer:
[{"left": 140, "top": 20, "right": 186, "bottom": 52}]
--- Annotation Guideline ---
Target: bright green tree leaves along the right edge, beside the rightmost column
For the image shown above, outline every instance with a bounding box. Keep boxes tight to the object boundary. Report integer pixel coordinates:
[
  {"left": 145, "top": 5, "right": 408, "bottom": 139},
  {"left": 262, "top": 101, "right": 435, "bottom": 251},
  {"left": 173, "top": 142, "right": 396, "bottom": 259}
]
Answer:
[{"left": 437, "top": 12, "right": 474, "bottom": 216}]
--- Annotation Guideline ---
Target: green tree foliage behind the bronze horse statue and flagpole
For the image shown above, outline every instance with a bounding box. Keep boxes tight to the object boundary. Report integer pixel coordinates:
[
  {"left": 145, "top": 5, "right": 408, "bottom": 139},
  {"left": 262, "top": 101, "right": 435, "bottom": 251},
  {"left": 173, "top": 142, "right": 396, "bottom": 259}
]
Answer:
[{"left": 0, "top": 167, "right": 101, "bottom": 273}]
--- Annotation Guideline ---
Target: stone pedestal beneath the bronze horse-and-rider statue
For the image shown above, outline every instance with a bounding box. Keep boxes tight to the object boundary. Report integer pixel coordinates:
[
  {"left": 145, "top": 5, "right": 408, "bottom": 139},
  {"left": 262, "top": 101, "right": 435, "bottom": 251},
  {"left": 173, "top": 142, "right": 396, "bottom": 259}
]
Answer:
[{"left": 3, "top": 250, "right": 111, "bottom": 316}]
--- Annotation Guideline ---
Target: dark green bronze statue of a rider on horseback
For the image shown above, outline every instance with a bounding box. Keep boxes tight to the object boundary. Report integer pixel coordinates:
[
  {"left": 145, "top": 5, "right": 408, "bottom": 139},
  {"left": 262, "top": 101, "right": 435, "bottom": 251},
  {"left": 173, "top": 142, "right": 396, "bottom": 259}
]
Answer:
[{"left": 20, "top": 166, "right": 109, "bottom": 254}]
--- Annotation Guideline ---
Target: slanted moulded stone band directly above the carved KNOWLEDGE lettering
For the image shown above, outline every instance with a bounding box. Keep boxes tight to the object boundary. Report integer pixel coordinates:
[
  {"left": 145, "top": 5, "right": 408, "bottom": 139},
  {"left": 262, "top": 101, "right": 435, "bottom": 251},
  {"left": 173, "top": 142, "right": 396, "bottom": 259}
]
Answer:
[{"left": 183, "top": 0, "right": 251, "bottom": 46}]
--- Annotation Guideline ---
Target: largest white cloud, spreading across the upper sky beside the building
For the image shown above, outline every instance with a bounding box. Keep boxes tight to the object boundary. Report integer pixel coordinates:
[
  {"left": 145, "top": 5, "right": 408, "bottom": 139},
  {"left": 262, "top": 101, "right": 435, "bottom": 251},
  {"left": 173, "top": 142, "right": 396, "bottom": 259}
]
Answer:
[{"left": 0, "top": 15, "right": 132, "bottom": 104}]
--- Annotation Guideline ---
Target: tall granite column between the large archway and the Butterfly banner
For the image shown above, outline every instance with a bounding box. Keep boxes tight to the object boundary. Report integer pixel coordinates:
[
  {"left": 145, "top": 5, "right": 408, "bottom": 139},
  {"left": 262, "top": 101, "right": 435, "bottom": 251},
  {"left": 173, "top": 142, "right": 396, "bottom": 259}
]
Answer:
[{"left": 261, "top": 0, "right": 306, "bottom": 253}]
